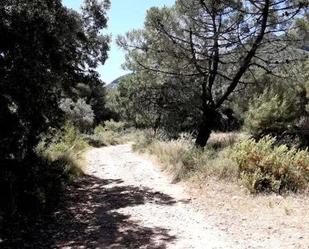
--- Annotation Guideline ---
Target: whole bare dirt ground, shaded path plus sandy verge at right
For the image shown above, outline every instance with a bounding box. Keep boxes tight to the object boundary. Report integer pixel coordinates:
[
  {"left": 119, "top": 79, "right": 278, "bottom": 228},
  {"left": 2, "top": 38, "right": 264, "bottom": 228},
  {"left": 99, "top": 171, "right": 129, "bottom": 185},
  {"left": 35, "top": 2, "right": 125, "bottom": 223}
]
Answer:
[{"left": 6, "top": 144, "right": 309, "bottom": 249}]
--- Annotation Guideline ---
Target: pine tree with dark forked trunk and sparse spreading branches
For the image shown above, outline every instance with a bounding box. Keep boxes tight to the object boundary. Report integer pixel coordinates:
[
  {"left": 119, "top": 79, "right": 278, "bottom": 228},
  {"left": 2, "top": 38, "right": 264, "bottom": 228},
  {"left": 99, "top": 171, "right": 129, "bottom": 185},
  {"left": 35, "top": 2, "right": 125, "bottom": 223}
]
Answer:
[{"left": 118, "top": 0, "right": 308, "bottom": 147}]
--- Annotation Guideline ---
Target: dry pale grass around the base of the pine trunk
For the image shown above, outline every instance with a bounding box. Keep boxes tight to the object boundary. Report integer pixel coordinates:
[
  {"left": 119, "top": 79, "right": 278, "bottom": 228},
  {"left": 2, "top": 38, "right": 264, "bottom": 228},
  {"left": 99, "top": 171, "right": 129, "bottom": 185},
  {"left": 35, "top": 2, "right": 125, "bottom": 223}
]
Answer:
[{"left": 134, "top": 133, "right": 238, "bottom": 181}]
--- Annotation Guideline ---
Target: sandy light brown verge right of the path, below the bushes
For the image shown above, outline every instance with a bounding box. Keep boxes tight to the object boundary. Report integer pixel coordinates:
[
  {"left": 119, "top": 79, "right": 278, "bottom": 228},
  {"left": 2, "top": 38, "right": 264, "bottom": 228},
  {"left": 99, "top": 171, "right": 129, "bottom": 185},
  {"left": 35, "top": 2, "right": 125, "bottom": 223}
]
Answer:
[{"left": 190, "top": 179, "right": 309, "bottom": 249}]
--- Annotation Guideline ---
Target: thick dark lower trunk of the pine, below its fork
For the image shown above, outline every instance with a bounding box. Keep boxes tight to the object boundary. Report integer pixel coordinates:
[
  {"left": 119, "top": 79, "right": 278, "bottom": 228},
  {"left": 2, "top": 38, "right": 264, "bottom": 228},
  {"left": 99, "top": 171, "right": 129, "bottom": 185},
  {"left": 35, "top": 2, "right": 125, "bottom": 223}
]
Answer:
[{"left": 195, "top": 109, "right": 220, "bottom": 148}]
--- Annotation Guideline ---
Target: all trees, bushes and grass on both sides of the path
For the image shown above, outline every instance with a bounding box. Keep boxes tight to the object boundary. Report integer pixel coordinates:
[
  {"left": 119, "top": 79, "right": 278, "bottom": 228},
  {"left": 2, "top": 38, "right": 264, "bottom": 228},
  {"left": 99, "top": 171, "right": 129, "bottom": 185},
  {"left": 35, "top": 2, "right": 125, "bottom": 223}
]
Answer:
[{"left": 0, "top": 0, "right": 309, "bottom": 243}]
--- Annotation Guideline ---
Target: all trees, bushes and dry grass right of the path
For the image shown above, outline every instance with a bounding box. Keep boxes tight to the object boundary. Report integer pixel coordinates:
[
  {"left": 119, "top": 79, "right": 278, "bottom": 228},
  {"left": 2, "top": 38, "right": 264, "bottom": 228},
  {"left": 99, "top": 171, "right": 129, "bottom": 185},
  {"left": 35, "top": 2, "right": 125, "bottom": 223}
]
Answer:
[{"left": 107, "top": 0, "right": 309, "bottom": 194}]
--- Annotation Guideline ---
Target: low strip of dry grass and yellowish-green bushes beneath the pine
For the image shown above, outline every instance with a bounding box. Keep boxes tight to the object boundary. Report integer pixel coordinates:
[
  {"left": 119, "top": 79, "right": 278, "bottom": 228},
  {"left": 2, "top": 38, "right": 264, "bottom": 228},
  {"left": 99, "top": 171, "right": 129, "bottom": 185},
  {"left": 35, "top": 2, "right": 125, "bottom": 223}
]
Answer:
[{"left": 133, "top": 133, "right": 309, "bottom": 193}]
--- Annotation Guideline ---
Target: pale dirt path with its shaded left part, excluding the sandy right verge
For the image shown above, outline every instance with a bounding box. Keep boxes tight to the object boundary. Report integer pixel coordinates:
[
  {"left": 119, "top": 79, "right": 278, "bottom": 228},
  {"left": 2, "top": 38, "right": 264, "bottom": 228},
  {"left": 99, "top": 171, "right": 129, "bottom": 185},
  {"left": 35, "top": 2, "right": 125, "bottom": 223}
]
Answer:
[{"left": 0, "top": 145, "right": 233, "bottom": 249}]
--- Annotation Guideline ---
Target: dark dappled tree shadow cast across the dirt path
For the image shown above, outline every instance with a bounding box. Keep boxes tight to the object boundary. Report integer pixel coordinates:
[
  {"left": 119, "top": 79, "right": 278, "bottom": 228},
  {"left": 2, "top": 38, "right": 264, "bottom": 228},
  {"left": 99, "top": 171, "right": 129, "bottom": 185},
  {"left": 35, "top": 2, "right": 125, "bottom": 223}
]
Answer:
[{"left": 3, "top": 175, "right": 176, "bottom": 249}]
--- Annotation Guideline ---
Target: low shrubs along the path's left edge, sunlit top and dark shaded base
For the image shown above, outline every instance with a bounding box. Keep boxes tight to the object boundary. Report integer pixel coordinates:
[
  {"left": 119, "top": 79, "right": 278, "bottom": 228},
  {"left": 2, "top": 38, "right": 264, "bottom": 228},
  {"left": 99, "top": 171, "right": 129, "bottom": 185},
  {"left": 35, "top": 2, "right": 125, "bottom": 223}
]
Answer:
[{"left": 0, "top": 123, "right": 88, "bottom": 215}]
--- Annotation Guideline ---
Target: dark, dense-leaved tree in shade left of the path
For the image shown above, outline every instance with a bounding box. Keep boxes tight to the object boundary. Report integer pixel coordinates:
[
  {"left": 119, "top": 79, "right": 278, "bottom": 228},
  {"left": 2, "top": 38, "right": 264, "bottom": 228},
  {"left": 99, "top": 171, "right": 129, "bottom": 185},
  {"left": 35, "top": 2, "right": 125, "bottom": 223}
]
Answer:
[{"left": 0, "top": 0, "right": 110, "bottom": 161}]
